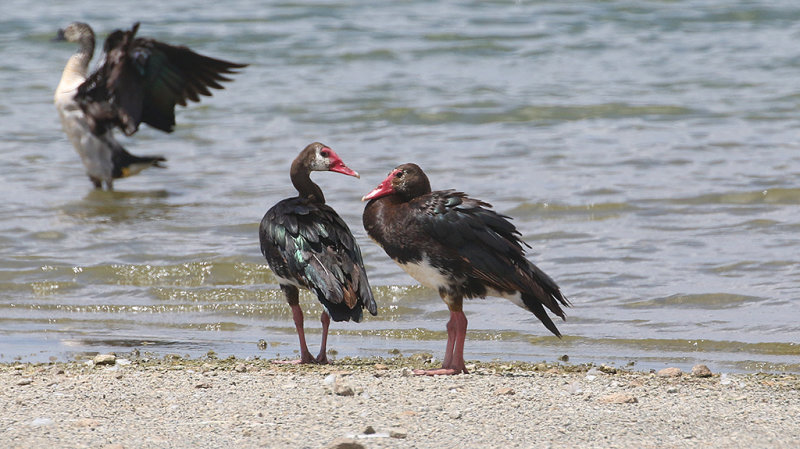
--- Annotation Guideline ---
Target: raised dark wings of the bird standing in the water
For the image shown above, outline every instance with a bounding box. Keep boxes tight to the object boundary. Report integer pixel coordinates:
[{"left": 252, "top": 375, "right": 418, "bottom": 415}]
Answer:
[{"left": 75, "top": 22, "right": 247, "bottom": 136}]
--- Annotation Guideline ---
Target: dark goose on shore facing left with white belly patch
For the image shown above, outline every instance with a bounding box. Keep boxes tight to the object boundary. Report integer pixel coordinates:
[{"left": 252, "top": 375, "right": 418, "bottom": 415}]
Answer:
[{"left": 363, "top": 164, "right": 569, "bottom": 375}]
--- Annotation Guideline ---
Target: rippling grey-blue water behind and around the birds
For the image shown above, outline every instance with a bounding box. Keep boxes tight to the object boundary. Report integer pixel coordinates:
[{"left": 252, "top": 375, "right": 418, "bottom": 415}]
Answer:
[{"left": 0, "top": 0, "right": 800, "bottom": 372}]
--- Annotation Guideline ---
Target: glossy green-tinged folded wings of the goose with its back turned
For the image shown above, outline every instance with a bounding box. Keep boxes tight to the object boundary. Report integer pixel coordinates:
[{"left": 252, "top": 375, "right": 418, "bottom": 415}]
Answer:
[{"left": 259, "top": 198, "right": 378, "bottom": 321}]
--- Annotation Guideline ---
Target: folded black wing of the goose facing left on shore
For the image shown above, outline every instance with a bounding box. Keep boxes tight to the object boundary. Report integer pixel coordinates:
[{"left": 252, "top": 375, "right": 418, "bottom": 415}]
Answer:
[{"left": 415, "top": 190, "right": 569, "bottom": 322}]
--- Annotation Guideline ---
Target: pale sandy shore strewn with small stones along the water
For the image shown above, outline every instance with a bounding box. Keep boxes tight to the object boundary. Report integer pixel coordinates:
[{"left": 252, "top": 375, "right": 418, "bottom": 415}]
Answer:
[{"left": 0, "top": 355, "right": 800, "bottom": 448}]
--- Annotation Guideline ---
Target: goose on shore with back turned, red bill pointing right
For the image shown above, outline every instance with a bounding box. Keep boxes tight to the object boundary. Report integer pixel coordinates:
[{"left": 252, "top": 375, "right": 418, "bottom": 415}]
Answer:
[{"left": 258, "top": 142, "right": 377, "bottom": 363}]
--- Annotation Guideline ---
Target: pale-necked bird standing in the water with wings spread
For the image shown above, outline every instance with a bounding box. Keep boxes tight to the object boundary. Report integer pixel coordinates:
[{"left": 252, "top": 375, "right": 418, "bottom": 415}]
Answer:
[{"left": 55, "top": 22, "right": 245, "bottom": 190}]
